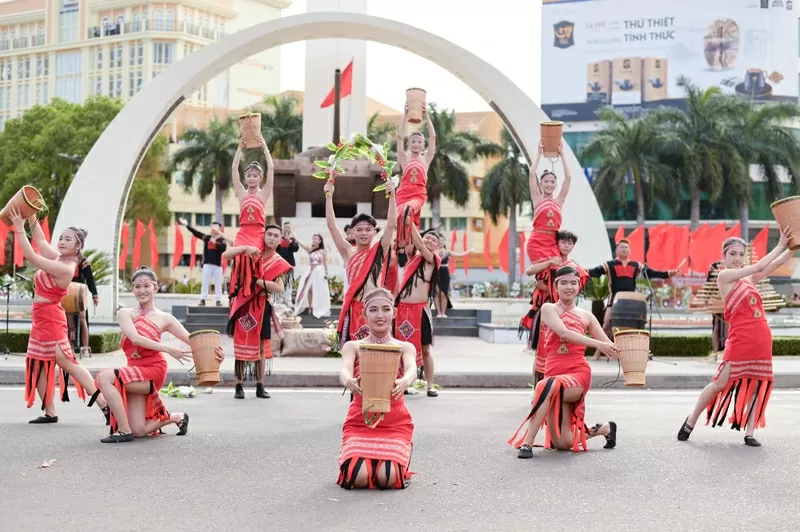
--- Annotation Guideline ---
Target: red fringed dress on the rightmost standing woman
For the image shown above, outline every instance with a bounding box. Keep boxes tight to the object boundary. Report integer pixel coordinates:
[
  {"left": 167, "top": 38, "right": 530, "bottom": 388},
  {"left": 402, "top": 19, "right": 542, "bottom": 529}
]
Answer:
[{"left": 706, "top": 279, "right": 774, "bottom": 430}]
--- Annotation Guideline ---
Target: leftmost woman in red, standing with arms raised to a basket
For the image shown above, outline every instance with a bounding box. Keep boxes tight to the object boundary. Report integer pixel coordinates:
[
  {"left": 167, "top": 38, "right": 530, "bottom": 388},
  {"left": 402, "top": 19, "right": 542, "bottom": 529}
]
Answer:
[{"left": 10, "top": 209, "right": 109, "bottom": 424}]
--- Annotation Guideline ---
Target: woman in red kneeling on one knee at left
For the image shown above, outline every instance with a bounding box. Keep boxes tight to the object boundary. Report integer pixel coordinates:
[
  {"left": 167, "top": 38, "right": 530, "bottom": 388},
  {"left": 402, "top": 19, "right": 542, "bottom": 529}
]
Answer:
[{"left": 89, "top": 266, "right": 225, "bottom": 443}]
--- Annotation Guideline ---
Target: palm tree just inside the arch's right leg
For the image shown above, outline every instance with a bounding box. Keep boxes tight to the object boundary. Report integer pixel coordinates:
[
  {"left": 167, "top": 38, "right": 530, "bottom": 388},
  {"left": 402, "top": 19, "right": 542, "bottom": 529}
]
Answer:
[{"left": 481, "top": 128, "right": 531, "bottom": 286}]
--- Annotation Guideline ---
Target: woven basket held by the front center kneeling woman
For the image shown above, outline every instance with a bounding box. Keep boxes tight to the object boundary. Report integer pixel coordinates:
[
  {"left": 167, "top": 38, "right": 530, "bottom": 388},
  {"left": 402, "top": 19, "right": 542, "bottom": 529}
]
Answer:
[{"left": 358, "top": 344, "right": 401, "bottom": 429}]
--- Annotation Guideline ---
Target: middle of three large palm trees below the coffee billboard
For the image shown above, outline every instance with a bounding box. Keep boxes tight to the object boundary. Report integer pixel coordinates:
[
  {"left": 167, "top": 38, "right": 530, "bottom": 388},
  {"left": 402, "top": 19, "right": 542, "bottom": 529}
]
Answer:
[{"left": 653, "top": 76, "right": 743, "bottom": 231}]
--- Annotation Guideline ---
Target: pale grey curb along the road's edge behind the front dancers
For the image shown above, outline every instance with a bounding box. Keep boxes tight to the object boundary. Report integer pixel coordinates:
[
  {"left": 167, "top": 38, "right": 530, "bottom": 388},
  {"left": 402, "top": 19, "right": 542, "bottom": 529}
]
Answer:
[{"left": 0, "top": 368, "right": 800, "bottom": 390}]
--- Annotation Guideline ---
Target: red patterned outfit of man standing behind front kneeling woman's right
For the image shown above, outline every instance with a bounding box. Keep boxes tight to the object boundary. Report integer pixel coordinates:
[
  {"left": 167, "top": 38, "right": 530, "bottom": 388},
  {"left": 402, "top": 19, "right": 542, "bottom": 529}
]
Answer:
[{"left": 394, "top": 253, "right": 441, "bottom": 368}]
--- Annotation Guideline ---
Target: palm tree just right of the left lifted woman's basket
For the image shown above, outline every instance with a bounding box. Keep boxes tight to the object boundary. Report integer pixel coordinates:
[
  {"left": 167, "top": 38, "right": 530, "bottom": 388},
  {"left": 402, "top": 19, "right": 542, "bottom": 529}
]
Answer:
[{"left": 261, "top": 96, "right": 303, "bottom": 159}]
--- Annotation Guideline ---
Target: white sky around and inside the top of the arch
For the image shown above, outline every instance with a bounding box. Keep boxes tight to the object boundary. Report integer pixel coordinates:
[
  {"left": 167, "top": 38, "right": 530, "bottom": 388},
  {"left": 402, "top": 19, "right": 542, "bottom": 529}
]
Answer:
[{"left": 281, "top": 0, "right": 540, "bottom": 112}]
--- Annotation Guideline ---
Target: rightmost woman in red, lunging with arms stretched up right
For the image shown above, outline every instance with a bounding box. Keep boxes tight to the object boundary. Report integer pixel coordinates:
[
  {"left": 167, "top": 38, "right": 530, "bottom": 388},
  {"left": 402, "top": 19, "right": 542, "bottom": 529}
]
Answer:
[{"left": 678, "top": 230, "right": 794, "bottom": 447}]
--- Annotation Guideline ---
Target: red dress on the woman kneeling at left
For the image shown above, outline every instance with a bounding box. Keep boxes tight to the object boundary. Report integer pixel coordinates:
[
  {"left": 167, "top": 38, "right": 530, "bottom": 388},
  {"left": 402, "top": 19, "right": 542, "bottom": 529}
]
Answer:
[{"left": 95, "top": 316, "right": 169, "bottom": 434}]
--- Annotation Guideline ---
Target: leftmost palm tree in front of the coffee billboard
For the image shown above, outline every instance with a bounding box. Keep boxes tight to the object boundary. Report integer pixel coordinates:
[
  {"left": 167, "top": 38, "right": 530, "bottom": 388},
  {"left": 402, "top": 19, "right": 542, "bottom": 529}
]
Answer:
[{"left": 582, "top": 107, "right": 678, "bottom": 225}]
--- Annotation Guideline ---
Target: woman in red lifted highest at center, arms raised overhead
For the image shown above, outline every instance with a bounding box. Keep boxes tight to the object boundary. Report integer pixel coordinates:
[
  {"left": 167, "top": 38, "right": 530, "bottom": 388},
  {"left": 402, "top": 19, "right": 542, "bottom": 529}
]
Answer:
[{"left": 397, "top": 104, "right": 436, "bottom": 268}]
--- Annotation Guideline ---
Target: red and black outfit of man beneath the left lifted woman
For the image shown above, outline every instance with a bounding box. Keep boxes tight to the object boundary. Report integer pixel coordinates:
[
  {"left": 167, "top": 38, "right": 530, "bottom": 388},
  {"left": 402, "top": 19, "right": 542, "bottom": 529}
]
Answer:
[{"left": 227, "top": 253, "right": 292, "bottom": 374}]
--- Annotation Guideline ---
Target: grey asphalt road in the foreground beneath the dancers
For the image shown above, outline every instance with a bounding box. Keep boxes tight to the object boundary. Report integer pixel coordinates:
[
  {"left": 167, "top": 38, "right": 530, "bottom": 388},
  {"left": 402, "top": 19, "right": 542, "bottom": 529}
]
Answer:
[{"left": 0, "top": 387, "right": 800, "bottom": 532}]
